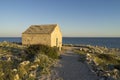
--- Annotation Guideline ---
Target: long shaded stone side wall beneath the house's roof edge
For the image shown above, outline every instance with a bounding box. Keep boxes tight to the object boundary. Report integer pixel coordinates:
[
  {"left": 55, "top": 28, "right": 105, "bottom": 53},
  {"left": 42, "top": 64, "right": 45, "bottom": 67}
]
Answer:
[{"left": 22, "top": 34, "right": 51, "bottom": 46}]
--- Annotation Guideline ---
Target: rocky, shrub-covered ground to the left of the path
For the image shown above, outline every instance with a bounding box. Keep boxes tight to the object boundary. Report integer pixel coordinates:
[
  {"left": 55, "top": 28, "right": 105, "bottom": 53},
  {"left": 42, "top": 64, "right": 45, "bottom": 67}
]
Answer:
[{"left": 0, "top": 41, "right": 56, "bottom": 80}]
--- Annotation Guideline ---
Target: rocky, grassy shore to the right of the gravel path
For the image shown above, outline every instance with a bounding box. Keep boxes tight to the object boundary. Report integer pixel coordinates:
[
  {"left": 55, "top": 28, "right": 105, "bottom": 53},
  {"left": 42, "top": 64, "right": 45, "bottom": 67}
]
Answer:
[{"left": 72, "top": 45, "right": 120, "bottom": 80}]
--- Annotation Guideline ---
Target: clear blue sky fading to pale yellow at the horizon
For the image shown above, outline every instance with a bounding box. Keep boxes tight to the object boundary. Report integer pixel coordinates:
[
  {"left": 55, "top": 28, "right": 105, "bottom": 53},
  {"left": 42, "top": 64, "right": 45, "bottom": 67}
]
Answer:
[{"left": 0, "top": 0, "right": 120, "bottom": 37}]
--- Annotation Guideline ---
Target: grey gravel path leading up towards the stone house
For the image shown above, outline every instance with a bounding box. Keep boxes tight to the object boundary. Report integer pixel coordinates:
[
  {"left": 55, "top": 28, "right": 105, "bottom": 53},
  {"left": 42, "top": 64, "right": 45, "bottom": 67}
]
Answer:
[{"left": 40, "top": 50, "right": 98, "bottom": 80}]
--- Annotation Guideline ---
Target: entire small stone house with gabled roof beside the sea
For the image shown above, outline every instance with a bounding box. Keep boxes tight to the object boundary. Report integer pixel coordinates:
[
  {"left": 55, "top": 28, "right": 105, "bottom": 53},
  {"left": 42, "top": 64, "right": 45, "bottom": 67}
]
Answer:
[{"left": 22, "top": 24, "right": 62, "bottom": 50}]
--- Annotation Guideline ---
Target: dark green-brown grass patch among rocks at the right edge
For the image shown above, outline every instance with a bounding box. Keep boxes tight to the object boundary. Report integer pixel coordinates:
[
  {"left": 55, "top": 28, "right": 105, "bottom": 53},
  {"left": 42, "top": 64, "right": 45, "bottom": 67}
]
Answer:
[{"left": 92, "top": 54, "right": 120, "bottom": 70}]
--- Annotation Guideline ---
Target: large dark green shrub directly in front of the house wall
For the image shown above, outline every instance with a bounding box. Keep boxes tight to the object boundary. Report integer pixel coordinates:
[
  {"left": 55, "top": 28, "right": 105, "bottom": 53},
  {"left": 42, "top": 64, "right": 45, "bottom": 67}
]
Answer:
[{"left": 25, "top": 45, "right": 59, "bottom": 59}]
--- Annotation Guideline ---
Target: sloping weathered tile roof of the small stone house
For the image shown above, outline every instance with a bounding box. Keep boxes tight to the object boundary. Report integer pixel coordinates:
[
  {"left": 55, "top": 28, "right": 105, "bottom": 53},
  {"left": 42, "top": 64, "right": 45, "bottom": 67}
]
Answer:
[{"left": 23, "top": 24, "right": 57, "bottom": 34}]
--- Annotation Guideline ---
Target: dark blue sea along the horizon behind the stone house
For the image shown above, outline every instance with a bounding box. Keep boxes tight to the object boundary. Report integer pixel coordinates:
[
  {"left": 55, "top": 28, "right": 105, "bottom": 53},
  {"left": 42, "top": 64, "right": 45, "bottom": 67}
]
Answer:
[{"left": 0, "top": 37, "right": 120, "bottom": 48}]
